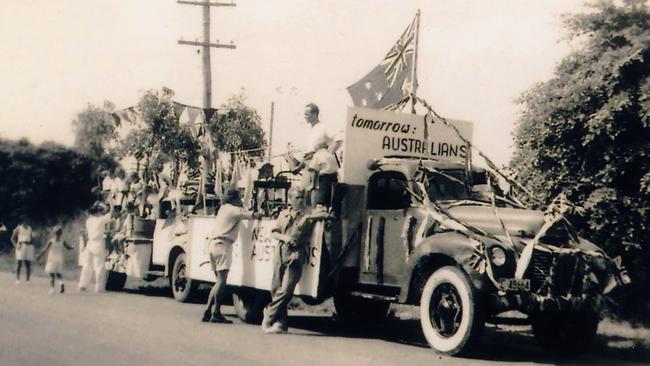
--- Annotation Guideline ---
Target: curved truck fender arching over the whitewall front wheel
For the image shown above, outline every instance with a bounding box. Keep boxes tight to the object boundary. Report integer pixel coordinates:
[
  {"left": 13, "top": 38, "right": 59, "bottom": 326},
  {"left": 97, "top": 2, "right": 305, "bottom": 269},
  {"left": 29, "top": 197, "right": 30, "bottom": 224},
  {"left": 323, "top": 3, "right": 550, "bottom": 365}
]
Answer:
[{"left": 399, "top": 231, "right": 486, "bottom": 303}]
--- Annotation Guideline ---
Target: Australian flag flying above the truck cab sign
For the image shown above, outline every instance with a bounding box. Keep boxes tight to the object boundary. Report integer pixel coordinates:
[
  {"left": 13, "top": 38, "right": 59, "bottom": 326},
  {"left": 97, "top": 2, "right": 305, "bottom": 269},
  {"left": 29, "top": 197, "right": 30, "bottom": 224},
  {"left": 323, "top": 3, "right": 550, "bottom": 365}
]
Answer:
[{"left": 348, "top": 12, "right": 420, "bottom": 109}]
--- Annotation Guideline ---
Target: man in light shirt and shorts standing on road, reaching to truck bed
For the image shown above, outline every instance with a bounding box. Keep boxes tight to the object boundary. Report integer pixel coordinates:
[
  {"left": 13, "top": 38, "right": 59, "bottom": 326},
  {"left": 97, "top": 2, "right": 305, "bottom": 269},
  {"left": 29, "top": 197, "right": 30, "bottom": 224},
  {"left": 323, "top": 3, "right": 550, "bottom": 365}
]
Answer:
[{"left": 201, "top": 188, "right": 262, "bottom": 324}]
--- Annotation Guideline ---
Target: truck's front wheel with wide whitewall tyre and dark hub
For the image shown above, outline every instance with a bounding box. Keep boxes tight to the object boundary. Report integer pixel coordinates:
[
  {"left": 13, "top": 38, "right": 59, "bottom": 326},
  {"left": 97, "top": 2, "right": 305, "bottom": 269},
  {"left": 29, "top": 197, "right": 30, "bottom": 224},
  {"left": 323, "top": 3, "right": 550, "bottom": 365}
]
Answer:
[{"left": 420, "top": 266, "right": 484, "bottom": 355}]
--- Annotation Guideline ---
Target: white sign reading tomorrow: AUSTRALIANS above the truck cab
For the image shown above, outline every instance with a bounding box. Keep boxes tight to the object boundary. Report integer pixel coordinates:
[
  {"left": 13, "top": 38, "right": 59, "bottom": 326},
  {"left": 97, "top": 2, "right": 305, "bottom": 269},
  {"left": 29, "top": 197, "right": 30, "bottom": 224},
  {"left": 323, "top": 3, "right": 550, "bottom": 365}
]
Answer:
[{"left": 342, "top": 107, "right": 473, "bottom": 184}]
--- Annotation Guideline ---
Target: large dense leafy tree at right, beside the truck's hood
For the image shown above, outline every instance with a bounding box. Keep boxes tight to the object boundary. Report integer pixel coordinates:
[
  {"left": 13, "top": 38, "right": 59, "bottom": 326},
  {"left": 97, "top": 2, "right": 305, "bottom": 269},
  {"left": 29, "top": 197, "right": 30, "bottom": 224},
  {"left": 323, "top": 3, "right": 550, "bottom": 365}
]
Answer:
[{"left": 511, "top": 0, "right": 650, "bottom": 313}]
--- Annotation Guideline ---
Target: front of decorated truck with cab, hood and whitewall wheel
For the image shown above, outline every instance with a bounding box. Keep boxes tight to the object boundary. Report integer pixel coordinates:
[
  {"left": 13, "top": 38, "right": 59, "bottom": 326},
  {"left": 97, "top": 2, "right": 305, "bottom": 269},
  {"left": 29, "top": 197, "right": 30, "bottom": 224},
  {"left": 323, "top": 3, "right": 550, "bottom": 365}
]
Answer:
[{"left": 326, "top": 158, "right": 621, "bottom": 355}]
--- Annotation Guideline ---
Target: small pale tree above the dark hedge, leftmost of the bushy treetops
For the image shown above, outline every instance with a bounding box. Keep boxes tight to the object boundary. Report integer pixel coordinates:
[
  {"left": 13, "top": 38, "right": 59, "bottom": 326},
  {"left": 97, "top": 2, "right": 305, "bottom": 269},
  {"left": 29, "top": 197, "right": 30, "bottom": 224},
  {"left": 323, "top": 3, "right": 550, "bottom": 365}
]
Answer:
[{"left": 72, "top": 101, "right": 117, "bottom": 158}]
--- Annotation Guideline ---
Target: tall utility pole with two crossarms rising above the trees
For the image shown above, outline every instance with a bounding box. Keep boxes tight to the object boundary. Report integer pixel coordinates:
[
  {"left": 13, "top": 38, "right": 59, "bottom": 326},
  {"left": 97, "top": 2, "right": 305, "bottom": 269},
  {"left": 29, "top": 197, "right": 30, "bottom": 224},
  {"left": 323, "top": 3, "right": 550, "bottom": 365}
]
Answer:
[{"left": 177, "top": 0, "right": 236, "bottom": 109}]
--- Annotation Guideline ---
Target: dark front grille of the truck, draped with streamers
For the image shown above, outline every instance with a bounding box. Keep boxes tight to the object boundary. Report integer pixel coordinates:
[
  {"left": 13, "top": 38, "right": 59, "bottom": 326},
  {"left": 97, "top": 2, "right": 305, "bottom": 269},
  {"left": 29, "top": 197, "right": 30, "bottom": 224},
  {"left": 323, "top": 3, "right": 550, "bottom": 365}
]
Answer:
[{"left": 524, "top": 249, "right": 586, "bottom": 296}]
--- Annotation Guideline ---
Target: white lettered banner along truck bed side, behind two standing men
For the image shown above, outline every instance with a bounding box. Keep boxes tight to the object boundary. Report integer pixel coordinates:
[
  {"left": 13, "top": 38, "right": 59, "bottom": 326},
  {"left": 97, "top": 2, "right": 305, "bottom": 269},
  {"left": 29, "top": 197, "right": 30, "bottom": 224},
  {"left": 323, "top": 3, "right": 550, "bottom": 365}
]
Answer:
[{"left": 189, "top": 216, "right": 323, "bottom": 297}]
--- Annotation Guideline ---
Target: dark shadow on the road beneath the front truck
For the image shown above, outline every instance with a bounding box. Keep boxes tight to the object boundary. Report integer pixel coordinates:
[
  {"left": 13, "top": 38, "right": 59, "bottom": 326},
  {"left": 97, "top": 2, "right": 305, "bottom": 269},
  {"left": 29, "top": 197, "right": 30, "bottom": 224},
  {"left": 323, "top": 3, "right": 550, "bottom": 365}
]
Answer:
[{"left": 290, "top": 316, "right": 650, "bottom": 365}]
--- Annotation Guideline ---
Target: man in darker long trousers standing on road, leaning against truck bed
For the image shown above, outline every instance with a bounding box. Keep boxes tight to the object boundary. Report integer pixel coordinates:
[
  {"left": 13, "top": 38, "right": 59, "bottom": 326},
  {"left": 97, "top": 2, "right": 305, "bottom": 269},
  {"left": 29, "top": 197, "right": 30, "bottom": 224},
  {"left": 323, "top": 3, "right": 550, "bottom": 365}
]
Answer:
[{"left": 262, "top": 187, "right": 329, "bottom": 333}]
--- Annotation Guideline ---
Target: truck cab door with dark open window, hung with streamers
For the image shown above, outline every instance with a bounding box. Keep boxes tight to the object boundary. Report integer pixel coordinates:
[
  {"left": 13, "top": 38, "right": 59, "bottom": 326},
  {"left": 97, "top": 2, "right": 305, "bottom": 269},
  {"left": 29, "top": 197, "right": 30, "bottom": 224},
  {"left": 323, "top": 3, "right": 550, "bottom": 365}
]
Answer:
[{"left": 359, "top": 172, "right": 411, "bottom": 286}]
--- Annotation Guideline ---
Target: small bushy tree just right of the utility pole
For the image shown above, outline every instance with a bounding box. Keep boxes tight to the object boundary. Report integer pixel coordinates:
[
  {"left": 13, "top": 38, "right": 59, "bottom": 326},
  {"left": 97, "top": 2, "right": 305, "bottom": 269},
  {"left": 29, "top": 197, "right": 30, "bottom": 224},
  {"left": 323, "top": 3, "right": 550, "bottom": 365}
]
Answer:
[{"left": 209, "top": 93, "right": 266, "bottom": 155}]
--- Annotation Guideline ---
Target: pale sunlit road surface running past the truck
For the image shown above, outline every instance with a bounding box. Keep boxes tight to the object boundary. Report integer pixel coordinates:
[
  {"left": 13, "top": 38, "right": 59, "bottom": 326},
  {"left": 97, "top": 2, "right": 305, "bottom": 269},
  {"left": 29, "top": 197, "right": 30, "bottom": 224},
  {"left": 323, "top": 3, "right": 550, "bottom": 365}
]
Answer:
[{"left": 0, "top": 272, "right": 648, "bottom": 366}]
